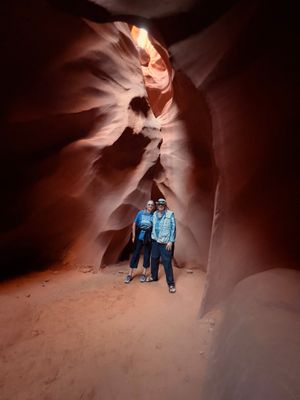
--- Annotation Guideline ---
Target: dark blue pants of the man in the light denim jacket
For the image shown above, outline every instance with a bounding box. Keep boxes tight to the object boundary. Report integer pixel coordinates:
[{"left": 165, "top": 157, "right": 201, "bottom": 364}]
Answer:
[{"left": 151, "top": 240, "right": 174, "bottom": 286}]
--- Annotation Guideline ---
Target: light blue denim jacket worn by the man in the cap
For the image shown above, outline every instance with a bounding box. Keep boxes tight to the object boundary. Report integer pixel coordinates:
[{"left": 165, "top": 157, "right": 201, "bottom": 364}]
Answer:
[{"left": 151, "top": 210, "right": 176, "bottom": 243}]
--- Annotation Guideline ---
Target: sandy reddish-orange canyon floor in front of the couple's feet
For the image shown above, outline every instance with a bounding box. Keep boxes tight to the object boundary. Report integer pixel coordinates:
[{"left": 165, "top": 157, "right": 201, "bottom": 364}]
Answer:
[{"left": 0, "top": 263, "right": 220, "bottom": 400}]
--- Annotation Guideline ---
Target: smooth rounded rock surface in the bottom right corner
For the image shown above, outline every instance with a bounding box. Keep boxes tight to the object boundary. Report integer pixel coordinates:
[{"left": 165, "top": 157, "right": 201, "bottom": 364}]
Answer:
[{"left": 201, "top": 269, "right": 300, "bottom": 400}]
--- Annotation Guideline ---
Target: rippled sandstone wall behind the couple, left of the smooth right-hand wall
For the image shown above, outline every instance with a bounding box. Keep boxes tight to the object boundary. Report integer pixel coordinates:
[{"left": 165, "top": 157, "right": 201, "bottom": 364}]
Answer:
[{"left": 1, "top": 1, "right": 214, "bottom": 275}]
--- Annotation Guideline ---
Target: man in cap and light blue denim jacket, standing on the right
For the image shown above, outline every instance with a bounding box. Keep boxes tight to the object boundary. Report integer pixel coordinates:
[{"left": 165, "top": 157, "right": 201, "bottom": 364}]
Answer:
[{"left": 147, "top": 199, "right": 176, "bottom": 293}]
